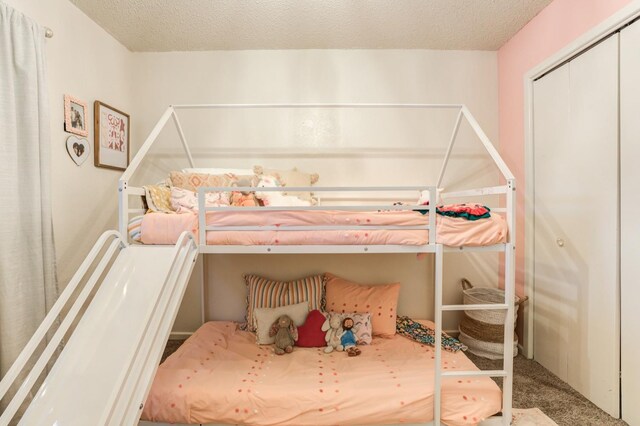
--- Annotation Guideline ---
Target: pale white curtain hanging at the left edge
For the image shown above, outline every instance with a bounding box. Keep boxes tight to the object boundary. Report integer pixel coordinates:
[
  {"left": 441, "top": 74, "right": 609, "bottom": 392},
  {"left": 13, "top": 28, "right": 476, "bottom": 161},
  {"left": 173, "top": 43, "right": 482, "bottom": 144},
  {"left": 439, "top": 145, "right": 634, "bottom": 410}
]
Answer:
[{"left": 0, "top": 1, "right": 58, "bottom": 377}]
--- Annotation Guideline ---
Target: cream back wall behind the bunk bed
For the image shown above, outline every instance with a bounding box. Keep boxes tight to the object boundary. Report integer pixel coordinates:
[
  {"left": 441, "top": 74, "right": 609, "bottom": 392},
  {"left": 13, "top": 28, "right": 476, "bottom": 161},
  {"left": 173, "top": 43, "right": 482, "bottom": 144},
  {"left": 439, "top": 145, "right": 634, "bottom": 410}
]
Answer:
[{"left": 133, "top": 50, "right": 498, "bottom": 330}]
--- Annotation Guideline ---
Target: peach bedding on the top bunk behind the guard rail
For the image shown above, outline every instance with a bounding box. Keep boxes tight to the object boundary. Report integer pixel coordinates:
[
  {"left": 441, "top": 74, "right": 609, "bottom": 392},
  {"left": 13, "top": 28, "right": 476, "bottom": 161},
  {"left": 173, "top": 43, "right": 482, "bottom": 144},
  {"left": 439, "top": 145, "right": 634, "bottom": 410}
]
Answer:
[{"left": 141, "top": 210, "right": 507, "bottom": 247}]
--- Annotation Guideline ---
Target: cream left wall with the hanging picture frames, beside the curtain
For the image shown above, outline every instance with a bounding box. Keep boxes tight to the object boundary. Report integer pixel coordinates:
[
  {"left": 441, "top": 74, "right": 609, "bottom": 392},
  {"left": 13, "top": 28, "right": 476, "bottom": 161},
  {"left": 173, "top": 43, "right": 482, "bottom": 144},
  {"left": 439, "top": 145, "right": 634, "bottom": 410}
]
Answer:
[{"left": 5, "top": 0, "right": 136, "bottom": 288}]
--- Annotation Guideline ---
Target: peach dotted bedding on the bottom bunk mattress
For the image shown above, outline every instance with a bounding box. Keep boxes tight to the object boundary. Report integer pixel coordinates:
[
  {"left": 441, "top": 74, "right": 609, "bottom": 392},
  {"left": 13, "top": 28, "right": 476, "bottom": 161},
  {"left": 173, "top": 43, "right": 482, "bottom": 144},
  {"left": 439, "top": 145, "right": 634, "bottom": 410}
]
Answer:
[{"left": 142, "top": 321, "right": 501, "bottom": 425}]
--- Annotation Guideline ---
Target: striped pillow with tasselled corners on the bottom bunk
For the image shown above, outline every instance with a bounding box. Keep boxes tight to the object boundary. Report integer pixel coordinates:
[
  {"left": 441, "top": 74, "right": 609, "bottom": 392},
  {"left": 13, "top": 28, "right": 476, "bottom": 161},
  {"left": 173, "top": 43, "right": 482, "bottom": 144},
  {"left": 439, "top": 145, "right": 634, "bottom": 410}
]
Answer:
[{"left": 243, "top": 274, "right": 325, "bottom": 331}]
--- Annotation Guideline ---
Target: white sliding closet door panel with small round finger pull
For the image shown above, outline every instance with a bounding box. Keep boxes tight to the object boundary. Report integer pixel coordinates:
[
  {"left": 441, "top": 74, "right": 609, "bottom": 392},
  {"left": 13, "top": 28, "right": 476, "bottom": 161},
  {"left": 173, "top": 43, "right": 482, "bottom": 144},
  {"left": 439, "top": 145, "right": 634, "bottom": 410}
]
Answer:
[{"left": 533, "top": 34, "right": 620, "bottom": 417}]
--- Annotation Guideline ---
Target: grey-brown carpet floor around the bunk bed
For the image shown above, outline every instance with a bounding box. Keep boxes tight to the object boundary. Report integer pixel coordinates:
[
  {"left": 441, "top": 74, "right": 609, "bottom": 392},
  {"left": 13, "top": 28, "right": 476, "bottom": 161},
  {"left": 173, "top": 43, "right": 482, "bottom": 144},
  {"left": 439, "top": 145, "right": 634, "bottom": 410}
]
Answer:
[{"left": 162, "top": 340, "right": 627, "bottom": 426}]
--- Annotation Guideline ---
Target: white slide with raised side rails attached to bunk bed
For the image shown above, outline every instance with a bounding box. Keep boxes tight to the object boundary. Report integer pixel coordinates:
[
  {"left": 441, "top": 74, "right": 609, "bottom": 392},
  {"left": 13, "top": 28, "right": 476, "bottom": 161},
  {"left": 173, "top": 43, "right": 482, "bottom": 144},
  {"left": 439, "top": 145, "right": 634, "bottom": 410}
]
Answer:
[{"left": 0, "top": 231, "right": 198, "bottom": 426}]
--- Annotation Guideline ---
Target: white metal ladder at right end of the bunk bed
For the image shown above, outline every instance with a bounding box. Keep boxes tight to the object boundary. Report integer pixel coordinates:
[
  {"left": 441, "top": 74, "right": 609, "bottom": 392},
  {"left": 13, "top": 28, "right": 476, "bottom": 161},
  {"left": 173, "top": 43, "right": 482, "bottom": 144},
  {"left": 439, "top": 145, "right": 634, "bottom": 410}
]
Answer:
[{"left": 433, "top": 243, "right": 515, "bottom": 426}]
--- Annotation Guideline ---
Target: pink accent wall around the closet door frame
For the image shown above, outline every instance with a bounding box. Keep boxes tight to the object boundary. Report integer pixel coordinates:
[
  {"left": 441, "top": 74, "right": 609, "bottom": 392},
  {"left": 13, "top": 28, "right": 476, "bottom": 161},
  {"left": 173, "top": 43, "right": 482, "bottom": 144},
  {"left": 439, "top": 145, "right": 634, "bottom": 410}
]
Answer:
[{"left": 498, "top": 0, "right": 630, "bottom": 300}]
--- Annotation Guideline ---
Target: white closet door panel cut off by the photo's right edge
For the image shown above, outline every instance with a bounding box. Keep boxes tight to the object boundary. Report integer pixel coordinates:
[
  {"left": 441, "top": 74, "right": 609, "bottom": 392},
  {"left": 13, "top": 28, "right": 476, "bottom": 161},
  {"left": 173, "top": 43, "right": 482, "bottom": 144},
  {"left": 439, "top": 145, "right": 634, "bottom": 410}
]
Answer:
[{"left": 620, "top": 22, "right": 640, "bottom": 425}]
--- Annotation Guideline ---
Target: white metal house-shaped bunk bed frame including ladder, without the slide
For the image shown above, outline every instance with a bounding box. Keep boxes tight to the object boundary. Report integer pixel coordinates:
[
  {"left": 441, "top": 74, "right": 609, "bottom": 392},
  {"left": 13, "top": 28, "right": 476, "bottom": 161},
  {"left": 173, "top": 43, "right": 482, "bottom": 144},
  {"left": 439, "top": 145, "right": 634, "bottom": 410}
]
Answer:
[{"left": 119, "top": 103, "right": 516, "bottom": 426}]
